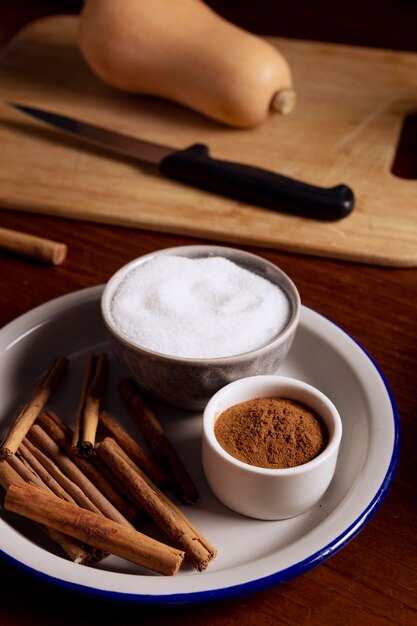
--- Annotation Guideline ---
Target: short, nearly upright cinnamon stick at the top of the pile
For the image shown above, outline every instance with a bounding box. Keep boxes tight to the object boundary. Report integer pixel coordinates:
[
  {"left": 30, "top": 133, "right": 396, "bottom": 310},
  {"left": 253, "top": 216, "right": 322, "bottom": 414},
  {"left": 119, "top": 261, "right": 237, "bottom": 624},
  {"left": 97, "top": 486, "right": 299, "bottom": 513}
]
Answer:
[{"left": 72, "top": 352, "right": 107, "bottom": 455}]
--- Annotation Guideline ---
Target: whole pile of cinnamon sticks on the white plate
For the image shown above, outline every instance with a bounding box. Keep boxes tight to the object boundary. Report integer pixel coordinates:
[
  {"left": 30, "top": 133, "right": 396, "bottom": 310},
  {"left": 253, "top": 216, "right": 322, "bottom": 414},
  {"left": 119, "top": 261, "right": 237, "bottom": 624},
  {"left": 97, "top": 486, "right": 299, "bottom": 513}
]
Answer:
[{"left": 0, "top": 353, "right": 217, "bottom": 575}]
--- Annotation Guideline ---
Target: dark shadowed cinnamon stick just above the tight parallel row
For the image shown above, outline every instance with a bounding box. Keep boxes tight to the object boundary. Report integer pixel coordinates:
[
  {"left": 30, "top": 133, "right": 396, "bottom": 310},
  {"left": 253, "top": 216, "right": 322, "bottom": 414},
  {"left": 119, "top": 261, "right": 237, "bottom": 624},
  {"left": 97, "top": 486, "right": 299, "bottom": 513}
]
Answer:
[{"left": 38, "top": 411, "right": 143, "bottom": 523}]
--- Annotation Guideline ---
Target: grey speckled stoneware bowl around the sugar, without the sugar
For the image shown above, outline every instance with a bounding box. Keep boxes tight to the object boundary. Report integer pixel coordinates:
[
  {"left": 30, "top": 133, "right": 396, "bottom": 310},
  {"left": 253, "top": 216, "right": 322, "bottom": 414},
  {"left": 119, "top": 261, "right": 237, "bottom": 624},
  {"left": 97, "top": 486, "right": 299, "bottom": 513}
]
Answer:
[{"left": 101, "top": 246, "right": 301, "bottom": 410}]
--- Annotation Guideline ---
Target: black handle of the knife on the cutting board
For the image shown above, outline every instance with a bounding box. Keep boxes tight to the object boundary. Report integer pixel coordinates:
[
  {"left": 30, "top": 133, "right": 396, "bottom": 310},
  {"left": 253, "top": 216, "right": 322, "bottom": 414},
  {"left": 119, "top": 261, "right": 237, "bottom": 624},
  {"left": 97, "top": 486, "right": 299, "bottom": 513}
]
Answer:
[{"left": 159, "top": 144, "right": 355, "bottom": 221}]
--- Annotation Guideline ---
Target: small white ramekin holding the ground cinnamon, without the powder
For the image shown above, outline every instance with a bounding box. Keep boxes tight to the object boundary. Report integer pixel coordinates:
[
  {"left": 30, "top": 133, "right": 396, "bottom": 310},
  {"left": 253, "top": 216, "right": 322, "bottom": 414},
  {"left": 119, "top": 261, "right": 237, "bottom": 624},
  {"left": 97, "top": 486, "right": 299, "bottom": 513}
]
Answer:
[{"left": 202, "top": 375, "right": 342, "bottom": 520}]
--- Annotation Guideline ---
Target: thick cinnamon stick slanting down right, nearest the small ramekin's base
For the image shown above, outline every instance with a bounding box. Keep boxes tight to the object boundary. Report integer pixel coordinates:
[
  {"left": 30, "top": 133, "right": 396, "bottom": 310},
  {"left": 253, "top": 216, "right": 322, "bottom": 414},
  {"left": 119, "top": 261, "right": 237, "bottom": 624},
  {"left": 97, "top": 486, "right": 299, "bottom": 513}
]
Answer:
[{"left": 97, "top": 437, "right": 216, "bottom": 571}]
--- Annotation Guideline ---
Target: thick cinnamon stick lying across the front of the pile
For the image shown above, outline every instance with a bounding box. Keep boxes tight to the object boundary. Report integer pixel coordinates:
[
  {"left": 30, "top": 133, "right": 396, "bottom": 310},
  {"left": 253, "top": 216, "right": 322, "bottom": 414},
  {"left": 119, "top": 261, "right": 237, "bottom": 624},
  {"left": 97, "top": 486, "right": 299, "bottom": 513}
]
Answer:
[{"left": 4, "top": 484, "right": 184, "bottom": 576}]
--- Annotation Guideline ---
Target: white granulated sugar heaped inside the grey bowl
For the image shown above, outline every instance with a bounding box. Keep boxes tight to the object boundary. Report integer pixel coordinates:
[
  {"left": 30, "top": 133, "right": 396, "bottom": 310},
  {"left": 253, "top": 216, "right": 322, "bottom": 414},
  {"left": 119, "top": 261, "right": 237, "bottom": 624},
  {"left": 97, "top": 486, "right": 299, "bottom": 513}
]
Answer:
[{"left": 111, "top": 255, "right": 290, "bottom": 358}]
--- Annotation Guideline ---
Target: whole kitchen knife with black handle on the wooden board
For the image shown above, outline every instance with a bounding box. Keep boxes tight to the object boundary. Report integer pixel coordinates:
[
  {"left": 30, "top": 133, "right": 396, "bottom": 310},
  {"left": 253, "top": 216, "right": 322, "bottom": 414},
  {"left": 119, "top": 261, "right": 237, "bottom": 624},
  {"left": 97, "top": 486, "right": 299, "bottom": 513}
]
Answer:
[{"left": 8, "top": 102, "right": 355, "bottom": 221}]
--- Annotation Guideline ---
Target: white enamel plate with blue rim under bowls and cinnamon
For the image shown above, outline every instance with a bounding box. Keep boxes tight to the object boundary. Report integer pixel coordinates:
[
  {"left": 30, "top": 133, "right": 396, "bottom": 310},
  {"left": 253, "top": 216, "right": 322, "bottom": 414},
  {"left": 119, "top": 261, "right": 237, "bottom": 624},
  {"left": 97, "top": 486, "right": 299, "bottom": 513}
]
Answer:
[{"left": 0, "top": 286, "right": 399, "bottom": 604}]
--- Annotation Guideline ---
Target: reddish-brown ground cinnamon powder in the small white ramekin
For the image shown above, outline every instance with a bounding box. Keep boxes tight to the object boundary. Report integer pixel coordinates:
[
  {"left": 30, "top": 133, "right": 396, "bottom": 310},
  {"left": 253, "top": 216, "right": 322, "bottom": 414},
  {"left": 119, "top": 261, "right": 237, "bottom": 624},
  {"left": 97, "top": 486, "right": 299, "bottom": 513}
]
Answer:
[{"left": 214, "top": 398, "right": 328, "bottom": 469}]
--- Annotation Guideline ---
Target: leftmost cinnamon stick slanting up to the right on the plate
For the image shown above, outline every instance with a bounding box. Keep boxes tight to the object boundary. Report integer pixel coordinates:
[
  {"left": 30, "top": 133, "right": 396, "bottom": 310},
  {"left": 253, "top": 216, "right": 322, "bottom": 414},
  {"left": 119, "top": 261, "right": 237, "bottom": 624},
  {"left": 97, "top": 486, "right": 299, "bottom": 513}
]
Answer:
[{"left": 0, "top": 357, "right": 69, "bottom": 461}]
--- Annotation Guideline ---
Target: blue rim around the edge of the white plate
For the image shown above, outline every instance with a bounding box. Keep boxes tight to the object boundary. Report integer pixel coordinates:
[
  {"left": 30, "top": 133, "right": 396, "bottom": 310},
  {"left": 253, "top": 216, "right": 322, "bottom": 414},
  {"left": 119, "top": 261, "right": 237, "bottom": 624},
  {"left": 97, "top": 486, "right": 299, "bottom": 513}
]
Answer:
[{"left": 0, "top": 285, "right": 401, "bottom": 606}]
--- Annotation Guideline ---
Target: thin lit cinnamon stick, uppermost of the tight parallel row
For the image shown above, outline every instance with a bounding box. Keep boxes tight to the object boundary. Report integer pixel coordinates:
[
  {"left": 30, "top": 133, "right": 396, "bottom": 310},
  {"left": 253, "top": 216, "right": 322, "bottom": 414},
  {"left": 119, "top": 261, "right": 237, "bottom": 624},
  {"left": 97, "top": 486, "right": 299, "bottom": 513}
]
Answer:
[{"left": 29, "top": 424, "right": 132, "bottom": 527}]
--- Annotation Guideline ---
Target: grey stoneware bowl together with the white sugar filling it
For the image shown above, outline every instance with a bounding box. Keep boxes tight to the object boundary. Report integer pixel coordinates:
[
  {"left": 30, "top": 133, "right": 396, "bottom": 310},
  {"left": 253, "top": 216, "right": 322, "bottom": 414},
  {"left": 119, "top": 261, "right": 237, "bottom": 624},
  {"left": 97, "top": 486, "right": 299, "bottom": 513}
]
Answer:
[{"left": 102, "top": 246, "right": 300, "bottom": 409}]
